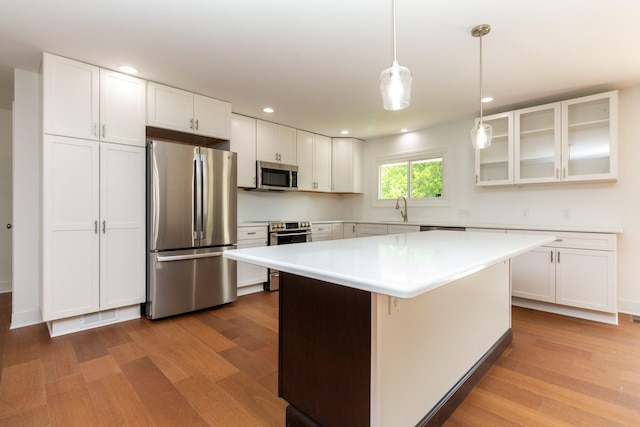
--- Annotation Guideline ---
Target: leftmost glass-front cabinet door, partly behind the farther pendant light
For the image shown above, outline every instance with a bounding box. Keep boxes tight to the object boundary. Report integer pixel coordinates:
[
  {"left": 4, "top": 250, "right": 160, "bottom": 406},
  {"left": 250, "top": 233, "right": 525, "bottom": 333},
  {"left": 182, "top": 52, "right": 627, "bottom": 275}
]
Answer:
[{"left": 475, "top": 111, "right": 513, "bottom": 186}]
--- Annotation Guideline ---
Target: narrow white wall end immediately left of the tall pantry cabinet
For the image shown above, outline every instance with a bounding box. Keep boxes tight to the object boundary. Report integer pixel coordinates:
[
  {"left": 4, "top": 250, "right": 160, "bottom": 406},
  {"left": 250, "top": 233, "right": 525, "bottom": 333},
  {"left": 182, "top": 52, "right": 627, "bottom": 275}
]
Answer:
[{"left": 11, "top": 70, "right": 42, "bottom": 328}]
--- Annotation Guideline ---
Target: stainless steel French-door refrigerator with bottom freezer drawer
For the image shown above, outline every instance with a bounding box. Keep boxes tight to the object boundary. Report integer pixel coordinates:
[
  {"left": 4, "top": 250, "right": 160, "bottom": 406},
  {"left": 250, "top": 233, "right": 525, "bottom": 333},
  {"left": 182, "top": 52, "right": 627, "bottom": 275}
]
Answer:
[{"left": 145, "top": 140, "right": 237, "bottom": 319}]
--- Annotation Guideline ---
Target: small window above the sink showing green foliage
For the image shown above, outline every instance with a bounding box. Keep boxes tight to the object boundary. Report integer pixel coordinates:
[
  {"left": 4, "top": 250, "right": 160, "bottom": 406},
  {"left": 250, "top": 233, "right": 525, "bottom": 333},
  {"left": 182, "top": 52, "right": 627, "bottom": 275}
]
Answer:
[{"left": 378, "top": 152, "right": 446, "bottom": 205}]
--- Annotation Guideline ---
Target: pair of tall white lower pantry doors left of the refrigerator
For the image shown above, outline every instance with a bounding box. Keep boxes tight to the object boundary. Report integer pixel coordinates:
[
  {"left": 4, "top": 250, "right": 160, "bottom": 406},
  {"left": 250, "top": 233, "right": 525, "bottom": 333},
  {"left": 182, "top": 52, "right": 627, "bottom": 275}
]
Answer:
[{"left": 41, "top": 135, "right": 146, "bottom": 321}]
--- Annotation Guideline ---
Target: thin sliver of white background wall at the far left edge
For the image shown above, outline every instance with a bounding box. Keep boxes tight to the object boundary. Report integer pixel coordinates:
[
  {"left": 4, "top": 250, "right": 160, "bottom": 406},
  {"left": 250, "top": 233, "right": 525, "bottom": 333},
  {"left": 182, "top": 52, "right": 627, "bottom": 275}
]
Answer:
[{"left": 0, "top": 109, "right": 13, "bottom": 293}]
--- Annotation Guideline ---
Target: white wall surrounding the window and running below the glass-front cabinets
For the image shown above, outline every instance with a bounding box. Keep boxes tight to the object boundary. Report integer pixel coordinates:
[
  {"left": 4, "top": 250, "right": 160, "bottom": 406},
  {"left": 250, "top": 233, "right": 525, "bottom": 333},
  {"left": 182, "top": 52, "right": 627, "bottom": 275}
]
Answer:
[{"left": 342, "top": 88, "right": 640, "bottom": 314}]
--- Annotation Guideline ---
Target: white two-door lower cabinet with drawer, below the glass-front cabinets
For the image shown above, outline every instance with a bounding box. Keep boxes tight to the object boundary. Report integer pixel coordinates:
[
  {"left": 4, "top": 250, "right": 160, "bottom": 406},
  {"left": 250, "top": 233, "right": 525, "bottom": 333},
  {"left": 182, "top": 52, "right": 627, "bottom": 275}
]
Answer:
[{"left": 508, "top": 230, "right": 617, "bottom": 318}]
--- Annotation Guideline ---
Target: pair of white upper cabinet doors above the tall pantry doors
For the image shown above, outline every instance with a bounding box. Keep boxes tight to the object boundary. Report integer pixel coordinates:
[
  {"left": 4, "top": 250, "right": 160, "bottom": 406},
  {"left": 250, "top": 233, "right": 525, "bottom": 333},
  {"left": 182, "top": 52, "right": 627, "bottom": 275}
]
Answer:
[{"left": 42, "top": 53, "right": 145, "bottom": 146}]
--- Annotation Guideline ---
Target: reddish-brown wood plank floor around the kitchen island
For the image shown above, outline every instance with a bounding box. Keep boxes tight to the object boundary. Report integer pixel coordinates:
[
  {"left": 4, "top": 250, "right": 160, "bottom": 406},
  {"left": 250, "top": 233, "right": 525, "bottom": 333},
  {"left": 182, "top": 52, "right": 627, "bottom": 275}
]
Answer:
[{"left": 0, "top": 292, "right": 640, "bottom": 426}]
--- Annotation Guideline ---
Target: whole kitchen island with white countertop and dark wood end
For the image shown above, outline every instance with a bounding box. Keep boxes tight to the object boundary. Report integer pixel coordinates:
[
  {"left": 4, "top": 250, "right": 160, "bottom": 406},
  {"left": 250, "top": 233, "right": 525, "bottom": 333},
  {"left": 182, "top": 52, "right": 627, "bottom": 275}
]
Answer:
[{"left": 224, "top": 231, "right": 554, "bottom": 426}]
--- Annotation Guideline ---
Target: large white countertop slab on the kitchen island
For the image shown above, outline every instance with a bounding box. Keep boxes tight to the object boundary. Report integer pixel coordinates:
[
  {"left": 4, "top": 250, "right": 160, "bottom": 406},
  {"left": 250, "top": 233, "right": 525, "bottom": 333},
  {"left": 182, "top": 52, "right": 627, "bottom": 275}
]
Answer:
[{"left": 224, "top": 231, "right": 555, "bottom": 298}]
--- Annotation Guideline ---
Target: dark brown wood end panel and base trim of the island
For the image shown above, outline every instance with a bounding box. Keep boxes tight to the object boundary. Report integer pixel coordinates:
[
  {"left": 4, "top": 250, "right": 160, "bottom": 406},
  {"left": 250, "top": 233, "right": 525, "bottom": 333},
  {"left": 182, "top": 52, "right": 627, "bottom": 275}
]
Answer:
[{"left": 278, "top": 272, "right": 512, "bottom": 427}]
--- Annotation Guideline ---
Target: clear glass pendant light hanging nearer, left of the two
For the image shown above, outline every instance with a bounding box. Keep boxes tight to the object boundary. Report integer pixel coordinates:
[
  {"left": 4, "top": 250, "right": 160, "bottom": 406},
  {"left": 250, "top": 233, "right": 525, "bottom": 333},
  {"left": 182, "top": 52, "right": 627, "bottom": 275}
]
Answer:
[{"left": 380, "top": 0, "right": 412, "bottom": 111}]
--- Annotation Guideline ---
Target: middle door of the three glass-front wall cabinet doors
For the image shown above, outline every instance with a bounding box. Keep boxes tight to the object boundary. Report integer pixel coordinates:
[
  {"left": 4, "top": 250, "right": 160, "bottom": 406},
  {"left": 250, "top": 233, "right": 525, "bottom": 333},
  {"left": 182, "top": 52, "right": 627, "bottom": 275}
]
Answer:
[{"left": 514, "top": 102, "right": 561, "bottom": 184}]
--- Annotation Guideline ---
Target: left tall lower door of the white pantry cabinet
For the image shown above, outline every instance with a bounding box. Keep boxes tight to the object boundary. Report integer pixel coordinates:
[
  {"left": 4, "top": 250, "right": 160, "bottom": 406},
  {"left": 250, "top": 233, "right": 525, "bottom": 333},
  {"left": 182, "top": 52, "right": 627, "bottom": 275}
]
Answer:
[{"left": 42, "top": 135, "right": 100, "bottom": 321}]
